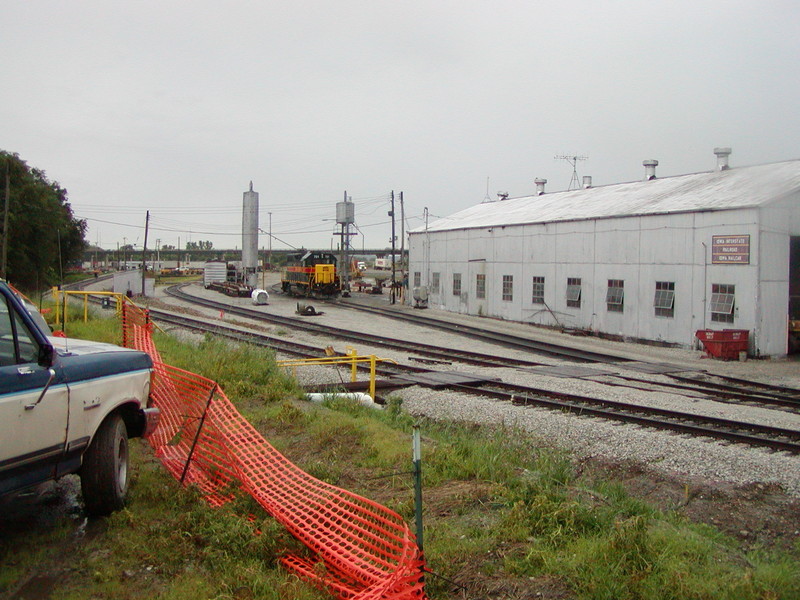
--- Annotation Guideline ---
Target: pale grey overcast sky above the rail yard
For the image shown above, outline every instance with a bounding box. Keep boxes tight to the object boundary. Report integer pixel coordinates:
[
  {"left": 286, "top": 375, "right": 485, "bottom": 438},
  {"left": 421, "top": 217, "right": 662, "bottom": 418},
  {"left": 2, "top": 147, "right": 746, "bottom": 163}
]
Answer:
[{"left": 0, "top": 0, "right": 800, "bottom": 249}]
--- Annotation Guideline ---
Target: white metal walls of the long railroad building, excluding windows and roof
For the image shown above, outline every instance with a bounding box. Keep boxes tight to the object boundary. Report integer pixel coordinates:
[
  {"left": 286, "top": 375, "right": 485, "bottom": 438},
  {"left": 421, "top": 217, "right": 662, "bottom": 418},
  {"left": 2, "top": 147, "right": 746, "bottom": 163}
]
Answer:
[{"left": 410, "top": 209, "right": 788, "bottom": 354}]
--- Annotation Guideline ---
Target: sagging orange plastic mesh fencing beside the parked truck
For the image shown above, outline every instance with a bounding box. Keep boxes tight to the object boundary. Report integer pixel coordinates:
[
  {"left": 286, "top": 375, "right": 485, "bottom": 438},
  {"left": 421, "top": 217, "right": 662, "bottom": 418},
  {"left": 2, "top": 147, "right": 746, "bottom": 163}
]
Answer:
[{"left": 123, "top": 308, "right": 426, "bottom": 600}]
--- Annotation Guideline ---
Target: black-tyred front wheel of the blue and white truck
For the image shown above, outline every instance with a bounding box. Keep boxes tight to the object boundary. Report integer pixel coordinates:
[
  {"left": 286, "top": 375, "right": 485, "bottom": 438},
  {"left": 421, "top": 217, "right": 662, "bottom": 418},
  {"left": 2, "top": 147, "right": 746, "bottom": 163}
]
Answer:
[{"left": 81, "top": 415, "right": 128, "bottom": 515}]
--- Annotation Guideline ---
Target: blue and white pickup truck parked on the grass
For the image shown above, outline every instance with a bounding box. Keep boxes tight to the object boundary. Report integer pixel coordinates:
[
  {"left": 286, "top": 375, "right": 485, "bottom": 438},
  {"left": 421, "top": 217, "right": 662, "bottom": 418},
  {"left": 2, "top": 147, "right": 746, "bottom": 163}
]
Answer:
[{"left": 0, "top": 280, "right": 159, "bottom": 515}]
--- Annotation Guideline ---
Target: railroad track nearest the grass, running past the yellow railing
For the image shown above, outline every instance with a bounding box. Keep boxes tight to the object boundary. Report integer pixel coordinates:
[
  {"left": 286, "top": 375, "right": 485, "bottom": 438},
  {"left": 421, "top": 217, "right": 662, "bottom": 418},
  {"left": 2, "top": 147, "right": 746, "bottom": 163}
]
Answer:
[{"left": 144, "top": 310, "right": 800, "bottom": 453}]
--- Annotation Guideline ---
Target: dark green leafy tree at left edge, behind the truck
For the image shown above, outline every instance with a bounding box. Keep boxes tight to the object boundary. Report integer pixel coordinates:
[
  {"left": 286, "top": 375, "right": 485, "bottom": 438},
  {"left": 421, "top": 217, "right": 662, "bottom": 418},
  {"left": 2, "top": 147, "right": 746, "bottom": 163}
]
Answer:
[{"left": 0, "top": 150, "right": 86, "bottom": 289}]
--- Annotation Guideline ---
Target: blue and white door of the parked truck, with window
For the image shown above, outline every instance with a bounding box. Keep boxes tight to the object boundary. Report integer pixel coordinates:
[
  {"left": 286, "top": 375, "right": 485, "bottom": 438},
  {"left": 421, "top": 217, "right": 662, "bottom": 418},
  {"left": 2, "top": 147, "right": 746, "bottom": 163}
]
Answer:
[{"left": 0, "top": 286, "right": 69, "bottom": 493}]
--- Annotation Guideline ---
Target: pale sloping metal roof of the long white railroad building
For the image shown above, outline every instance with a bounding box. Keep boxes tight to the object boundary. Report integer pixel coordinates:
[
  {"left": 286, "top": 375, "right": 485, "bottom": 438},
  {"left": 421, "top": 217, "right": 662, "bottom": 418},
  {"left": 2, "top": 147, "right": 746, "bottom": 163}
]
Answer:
[{"left": 411, "top": 160, "right": 800, "bottom": 233}]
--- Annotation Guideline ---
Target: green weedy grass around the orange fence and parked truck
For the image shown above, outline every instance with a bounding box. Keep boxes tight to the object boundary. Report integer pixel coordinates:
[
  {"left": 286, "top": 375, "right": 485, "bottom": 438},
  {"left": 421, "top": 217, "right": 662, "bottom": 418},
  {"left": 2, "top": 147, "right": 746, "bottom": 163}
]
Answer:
[{"left": 0, "top": 310, "right": 800, "bottom": 600}]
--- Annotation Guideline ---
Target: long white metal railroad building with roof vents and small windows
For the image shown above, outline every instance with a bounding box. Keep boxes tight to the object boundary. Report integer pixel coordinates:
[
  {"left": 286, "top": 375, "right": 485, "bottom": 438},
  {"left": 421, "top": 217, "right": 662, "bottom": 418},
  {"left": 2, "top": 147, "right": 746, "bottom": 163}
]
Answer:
[{"left": 409, "top": 149, "right": 800, "bottom": 356}]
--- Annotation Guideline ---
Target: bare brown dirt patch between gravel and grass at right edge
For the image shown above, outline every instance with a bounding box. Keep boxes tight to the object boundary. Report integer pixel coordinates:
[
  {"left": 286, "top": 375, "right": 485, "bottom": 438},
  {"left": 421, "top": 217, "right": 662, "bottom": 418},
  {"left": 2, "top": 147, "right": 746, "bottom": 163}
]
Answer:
[{"left": 580, "top": 459, "right": 800, "bottom": 550}]
